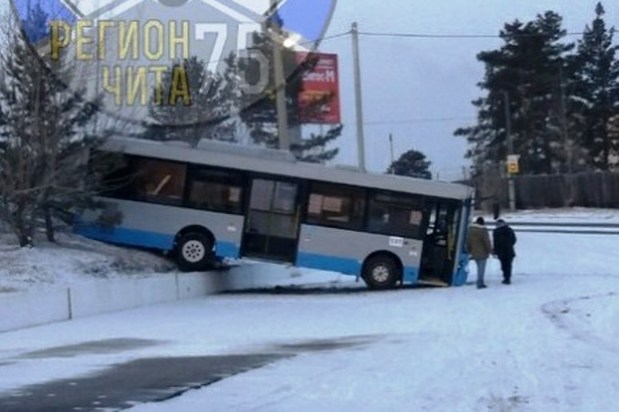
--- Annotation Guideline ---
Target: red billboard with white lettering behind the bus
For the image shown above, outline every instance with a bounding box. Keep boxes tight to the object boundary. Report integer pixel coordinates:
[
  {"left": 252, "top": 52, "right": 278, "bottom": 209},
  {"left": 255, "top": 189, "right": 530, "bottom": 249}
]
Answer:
[{"left": 296, "top": 53, "right": 341, "bottom": 124}]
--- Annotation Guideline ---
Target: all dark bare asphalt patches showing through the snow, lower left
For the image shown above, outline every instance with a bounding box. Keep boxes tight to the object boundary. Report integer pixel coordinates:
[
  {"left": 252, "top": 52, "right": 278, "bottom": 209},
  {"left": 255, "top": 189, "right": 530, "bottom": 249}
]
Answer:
[{"left": 0, "top": 334, "right": 372, "bottom": 412}]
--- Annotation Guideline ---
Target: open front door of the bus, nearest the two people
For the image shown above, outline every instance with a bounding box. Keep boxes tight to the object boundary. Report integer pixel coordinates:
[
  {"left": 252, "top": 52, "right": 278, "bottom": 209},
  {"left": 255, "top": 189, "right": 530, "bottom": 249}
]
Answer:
[{"left": 419, "top": 200, "right": 459, "bottom": 285}]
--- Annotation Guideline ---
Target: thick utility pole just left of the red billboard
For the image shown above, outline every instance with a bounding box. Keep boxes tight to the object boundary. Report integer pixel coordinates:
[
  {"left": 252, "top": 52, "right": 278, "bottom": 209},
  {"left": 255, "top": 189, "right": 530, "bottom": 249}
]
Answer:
[{"left": 271, "top": 0, "right": 290, "bottom": 150}]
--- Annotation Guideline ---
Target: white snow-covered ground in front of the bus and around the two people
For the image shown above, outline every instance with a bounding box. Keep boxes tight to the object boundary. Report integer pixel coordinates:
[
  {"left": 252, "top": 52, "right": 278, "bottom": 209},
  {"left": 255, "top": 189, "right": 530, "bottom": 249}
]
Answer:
[{"left": 0, "top": 210, "right": 619, "bottom": 412}]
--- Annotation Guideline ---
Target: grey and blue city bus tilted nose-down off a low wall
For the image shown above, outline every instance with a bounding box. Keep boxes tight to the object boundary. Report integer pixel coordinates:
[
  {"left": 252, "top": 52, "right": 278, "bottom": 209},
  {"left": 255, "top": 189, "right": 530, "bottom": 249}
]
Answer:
[{"left": 76, "top": 138, "right": 472, "bottom": 289}]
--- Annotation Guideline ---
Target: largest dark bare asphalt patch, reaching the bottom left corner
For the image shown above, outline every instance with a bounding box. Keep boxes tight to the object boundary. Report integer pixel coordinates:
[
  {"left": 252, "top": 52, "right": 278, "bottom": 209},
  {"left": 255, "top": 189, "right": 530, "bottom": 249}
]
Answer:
[{"left": 0, "top": 354, "right": 291, "bottom": 412}]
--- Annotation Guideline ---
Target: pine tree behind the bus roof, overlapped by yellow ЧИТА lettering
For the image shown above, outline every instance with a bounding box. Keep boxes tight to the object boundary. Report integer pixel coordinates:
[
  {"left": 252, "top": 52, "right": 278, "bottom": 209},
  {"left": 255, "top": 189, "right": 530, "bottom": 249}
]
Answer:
[{"left": 142, "top": 56, "right": 236, "bottom": 146}]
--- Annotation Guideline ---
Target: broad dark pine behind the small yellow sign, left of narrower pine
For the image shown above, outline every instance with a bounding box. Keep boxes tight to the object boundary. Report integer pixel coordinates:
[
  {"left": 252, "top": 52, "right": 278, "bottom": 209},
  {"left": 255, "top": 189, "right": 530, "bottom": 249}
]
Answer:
[{"left": 455, "top": 11, "right": 573, "bottom": 173}]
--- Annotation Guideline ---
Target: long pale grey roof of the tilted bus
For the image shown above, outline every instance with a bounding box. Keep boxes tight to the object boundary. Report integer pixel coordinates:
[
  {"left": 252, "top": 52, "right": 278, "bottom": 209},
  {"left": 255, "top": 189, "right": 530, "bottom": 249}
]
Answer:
[{"left": 102, "top": 137, "right": 472, "bottom": 199}]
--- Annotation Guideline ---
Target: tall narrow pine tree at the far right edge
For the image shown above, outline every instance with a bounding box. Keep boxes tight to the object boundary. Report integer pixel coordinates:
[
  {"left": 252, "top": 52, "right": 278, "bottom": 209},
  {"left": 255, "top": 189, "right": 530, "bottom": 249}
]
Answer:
[{"left": 571, "top": 3, "right": 619, "bottom": 170}]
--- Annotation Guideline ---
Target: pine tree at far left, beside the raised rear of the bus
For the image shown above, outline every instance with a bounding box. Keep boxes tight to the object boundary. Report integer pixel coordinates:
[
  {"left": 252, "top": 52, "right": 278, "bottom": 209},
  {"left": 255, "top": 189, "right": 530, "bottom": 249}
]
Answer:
[{"left": 0, "top": 4, "right": 101, "bottom": 246}]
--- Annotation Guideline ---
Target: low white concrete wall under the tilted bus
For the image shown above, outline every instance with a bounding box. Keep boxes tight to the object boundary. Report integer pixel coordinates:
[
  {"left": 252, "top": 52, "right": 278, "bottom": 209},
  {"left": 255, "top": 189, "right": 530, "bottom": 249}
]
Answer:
[{"left": 0, "top": 263, "right": 348, "bottom": 332}]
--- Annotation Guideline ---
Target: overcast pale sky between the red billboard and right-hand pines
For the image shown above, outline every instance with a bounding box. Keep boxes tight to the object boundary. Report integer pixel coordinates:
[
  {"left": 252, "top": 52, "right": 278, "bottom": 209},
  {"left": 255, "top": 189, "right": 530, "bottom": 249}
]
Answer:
[{"left": 321, "top": 0, "right": 619, "bottom": 179}]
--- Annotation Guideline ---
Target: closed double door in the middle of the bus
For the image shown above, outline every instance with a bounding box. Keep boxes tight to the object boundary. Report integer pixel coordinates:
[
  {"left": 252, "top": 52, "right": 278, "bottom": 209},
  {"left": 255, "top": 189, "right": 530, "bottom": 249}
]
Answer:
[{"left": 241, "top": 178, "right": 301, "bottom": 262}]
